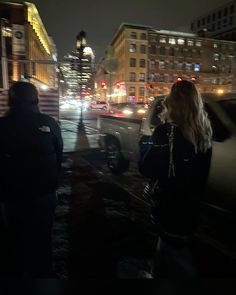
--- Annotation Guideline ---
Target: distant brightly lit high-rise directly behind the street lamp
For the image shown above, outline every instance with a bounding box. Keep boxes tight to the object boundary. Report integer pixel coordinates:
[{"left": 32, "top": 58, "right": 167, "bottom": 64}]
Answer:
[{"left": 60, "top": 34, "right": 95, "bottom": 99}]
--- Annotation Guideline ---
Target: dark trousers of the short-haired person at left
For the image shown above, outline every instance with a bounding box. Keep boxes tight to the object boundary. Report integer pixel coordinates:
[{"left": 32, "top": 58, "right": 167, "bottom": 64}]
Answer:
[{"left": 0, "top": 193, "right": 57, "bottom": 278}]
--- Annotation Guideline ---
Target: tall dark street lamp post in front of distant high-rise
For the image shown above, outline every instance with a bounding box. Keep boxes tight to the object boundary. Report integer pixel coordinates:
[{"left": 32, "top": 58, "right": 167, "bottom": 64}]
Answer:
[{"left": 76, "top": 31, "right": 87, "bottom": 131}]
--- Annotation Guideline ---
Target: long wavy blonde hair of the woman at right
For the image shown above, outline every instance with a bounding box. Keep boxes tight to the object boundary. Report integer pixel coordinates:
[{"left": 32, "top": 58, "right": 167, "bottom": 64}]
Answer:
[{"left": 161, "top": 80, "right": 212, "bottom": 152}]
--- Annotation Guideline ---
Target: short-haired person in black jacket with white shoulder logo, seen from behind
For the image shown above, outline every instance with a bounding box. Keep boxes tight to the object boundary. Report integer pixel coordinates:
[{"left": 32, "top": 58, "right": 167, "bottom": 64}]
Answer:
[{"left": 0, "top": 82, "right": 63, "bottom": 278}]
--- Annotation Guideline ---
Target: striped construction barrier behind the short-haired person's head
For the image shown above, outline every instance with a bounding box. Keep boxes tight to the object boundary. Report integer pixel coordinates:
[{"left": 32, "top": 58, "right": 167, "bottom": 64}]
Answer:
[{"left": 0, "top": 90, "right": 59, "bottom": 121}]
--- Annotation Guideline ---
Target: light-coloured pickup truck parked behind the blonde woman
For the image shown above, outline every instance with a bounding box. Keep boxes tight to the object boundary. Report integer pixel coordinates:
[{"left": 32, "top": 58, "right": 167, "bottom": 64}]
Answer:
[{"left": 98, "top": 93, "right": 236, "bottom": 212}]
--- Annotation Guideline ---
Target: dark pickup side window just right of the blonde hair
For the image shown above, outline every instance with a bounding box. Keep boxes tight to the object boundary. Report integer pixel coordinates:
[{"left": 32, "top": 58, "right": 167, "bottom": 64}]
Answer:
[{"left": 205, "top": 103, "right": 231, "bottom": 142}]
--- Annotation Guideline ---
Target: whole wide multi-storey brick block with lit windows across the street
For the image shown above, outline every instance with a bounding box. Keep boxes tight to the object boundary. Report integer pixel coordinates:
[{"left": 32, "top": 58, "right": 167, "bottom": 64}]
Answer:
[{"left": 95, "top": 23, "right": 236, "bottom": 102}]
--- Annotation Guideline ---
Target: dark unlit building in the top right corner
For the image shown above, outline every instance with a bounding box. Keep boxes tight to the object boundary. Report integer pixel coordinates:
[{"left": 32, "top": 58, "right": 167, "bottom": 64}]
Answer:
[{"left": 191, "top": 0, "right": 236, "bottom": 41}]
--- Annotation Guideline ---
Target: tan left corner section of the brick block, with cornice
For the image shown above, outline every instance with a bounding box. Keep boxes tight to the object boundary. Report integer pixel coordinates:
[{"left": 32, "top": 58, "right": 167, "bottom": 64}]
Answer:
[{"left": 95, "top": 23, "right": 152, "bottom": 102}]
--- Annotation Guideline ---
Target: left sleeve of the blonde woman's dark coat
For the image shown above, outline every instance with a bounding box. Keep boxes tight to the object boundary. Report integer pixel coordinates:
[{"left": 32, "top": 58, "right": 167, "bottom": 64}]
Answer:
[{"left": 138, "top": 124, "right": 169, "bottom": 179}]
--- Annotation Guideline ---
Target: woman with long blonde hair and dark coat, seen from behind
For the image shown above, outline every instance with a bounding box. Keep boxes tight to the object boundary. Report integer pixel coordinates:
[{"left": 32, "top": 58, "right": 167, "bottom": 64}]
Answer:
[{"left": 139, "top": 80, "right": 212, "bottom": 277}]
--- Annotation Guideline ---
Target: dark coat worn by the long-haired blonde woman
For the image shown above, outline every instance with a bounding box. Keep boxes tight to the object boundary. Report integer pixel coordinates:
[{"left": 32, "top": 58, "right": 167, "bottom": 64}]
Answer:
[{"left": 139, "top": 123, "right": 212, "bottom": 235}]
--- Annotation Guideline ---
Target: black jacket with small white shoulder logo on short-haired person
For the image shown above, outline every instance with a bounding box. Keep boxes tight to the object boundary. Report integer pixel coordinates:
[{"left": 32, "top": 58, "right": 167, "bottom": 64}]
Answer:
[{"left": 0, "top": 108, "right": 63, "bottom": 200}]
